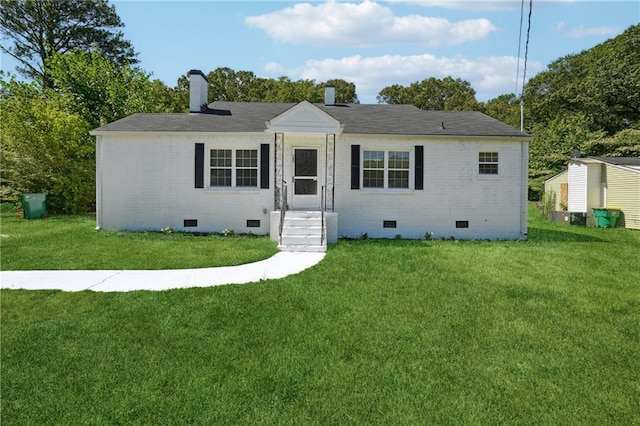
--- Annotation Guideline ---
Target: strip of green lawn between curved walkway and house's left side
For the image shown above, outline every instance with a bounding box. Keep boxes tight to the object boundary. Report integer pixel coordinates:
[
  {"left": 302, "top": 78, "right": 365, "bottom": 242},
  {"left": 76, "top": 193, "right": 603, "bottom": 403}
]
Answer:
[{"left": 0, "top": 207, "right": 277, "bottom": 271}]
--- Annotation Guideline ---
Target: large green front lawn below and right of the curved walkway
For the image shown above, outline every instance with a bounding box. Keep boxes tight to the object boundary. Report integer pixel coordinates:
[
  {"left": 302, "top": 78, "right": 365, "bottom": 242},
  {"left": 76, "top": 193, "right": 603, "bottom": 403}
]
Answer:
[{"left": 0, "top": 205, "right": 640, "bottom": 425}]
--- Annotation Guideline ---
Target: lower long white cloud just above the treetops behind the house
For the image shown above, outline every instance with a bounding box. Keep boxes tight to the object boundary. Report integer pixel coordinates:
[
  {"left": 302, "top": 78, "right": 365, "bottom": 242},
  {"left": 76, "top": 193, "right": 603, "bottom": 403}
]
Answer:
[{"left": 268, "top": 54, "right": 544, "bottom": 103}]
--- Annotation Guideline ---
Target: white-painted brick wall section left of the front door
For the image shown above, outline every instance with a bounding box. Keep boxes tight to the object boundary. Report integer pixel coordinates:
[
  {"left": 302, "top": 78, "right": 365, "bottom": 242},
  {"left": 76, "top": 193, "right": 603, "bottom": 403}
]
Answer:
[{"left": 98, "top": 134, "right": 273, "bottom": 234}]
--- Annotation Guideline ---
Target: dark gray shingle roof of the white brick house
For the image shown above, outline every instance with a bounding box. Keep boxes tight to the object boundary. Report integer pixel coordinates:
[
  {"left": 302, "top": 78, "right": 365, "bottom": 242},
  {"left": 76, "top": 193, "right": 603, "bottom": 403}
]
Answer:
[{"left": 94, "top": 102, "right": 529, "bottom": 137}]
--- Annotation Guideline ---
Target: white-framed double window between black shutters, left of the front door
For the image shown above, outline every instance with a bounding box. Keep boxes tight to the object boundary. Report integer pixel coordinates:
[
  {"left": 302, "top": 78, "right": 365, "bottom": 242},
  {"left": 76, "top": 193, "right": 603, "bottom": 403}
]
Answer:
[{"left": 210, "top": 149, "right": 258, "bottom": 188}]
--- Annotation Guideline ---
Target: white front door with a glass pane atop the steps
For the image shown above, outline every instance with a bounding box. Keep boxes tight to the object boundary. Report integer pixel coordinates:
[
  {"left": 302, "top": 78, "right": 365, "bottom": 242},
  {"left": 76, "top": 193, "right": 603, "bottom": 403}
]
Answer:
[{"left": 291, "top": 148, "right": 321, "bottom": 210}]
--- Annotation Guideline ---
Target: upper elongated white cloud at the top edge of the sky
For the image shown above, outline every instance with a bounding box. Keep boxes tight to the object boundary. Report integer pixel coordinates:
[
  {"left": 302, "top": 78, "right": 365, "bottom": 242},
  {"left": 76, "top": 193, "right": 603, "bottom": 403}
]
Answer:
[{"left": 245, "top": 1, "right": 496, "bottom": 47}]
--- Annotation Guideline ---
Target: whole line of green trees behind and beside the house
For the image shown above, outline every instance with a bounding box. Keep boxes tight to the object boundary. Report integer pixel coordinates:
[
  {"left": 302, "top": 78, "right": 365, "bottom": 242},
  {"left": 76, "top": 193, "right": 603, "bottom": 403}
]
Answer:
[{"left": 0, "top": 0, "right": 640, "bottom": 213}]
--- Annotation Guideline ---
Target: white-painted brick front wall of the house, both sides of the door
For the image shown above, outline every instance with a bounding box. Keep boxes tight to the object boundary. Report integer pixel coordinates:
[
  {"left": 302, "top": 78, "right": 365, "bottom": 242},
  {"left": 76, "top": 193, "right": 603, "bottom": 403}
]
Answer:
[{"left": 97, "top": 133, "right": 527, "bottom": 239}]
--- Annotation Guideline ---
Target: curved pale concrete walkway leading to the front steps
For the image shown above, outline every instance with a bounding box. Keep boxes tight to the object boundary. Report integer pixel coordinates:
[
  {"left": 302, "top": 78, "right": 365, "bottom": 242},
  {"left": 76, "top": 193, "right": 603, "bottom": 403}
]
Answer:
[{"left": 0, "top": 252, "right": 325, "bottom": 292}]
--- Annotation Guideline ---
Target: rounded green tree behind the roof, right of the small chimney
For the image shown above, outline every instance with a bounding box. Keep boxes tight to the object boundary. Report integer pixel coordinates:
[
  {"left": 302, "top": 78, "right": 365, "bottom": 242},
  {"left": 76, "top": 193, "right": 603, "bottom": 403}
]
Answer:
[{"left": 377, "top": 77, "right": 482, "bottom": 111}]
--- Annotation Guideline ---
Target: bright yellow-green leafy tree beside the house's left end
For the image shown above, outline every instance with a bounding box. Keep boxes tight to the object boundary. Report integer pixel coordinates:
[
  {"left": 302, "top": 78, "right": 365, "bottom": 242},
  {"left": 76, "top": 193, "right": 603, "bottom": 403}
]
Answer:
[{"left": 0, "top": 80, "right": 95, "bottom": 213}]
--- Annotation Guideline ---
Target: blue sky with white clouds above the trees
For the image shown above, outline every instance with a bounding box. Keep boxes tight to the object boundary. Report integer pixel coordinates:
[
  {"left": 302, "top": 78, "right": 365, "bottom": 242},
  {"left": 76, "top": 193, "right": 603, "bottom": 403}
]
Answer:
[{"left": 2, "top": 0, "right": 640, "bottom": 103}]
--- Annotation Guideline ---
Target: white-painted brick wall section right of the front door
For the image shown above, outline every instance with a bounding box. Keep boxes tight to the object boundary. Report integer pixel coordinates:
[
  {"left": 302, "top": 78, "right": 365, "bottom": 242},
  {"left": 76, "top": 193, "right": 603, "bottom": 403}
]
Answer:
[{"left": 336, "top": 136, "right": 526, "bottom": 239}]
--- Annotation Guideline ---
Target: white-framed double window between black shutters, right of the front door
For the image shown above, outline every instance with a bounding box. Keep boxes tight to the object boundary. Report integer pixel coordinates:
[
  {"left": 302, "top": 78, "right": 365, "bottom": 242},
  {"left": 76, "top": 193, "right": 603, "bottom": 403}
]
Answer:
[{"left": 362, "top": 151, "right": 409, "bottom": 188}]
